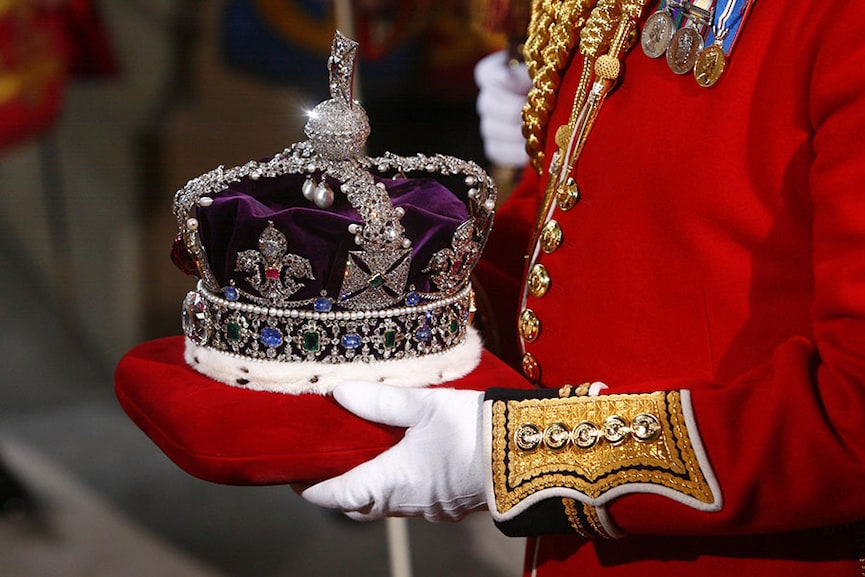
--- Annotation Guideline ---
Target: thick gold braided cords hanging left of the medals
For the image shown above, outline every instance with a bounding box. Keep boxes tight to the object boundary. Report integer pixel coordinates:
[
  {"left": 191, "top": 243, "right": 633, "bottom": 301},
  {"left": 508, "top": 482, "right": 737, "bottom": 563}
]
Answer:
[{"left": 523, "top": 0, "right": 646, "bottom": 173}]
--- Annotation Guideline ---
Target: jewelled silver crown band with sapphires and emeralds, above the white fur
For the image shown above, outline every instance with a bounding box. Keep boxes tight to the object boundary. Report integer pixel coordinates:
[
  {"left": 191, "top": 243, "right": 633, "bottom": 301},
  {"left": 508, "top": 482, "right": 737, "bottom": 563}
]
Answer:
[{"left": 183, "top": 283, "right": 473, "bottom": 363}]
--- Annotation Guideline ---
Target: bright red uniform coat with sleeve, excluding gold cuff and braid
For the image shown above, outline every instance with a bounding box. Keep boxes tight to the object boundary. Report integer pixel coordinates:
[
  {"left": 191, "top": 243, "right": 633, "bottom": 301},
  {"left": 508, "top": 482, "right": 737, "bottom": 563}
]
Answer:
[{"left": 472, "top": 0, "right": 865, "bottom": 577}]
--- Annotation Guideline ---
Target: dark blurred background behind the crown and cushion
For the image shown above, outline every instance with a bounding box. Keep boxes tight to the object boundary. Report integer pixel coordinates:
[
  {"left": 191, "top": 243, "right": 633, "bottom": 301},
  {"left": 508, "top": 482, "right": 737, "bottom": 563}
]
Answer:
[{"left": 0, "top": 0, "right": 523, "bottom": 577}]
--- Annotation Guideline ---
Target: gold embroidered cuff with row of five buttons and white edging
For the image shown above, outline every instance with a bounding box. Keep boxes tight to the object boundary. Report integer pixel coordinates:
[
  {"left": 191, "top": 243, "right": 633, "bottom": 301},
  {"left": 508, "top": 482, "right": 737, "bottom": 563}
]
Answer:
[{"left": 489, "top": 391, "right": 721, "bottom": 520}]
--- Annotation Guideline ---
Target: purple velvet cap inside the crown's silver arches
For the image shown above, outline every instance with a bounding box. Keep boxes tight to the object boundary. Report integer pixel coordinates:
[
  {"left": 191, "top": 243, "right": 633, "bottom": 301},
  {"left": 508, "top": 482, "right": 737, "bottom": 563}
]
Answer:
[{"left": 196, "top": 174, "right": 469, "bottom": 296}]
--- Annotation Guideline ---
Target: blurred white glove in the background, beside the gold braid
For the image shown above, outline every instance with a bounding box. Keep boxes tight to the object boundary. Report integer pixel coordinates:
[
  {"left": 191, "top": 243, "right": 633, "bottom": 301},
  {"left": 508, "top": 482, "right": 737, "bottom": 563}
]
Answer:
[{"left": 475, "top": 50, "right": 532, "bottom": 167}]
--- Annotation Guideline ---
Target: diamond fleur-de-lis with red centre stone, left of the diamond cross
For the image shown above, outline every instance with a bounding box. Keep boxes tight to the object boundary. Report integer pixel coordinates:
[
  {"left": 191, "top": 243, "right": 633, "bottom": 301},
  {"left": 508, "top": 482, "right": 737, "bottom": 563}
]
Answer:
[{"left": 235, "top": 221, "right": 315, "bottom": 305}]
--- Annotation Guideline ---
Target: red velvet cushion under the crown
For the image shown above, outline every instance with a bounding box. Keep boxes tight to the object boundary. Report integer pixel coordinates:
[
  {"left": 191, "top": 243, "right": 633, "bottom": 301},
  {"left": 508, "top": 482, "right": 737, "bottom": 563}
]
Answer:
[{"left": 115, "top": 336, "right": 529, "bottom": 485}]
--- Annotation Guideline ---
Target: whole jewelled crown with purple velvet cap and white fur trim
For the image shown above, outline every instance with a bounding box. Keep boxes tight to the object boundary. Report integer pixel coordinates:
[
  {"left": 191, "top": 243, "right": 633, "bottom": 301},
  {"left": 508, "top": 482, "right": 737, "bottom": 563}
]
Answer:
[{"left": 172, "top": 32, "right": 496, "bottom": 393}]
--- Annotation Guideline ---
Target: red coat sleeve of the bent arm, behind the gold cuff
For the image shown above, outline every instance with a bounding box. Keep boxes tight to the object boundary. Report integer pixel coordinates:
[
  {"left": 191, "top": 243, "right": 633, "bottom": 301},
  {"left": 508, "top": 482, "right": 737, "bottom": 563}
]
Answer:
[{"left": 480, "top": 5, "right": 865, "bottom": 535}]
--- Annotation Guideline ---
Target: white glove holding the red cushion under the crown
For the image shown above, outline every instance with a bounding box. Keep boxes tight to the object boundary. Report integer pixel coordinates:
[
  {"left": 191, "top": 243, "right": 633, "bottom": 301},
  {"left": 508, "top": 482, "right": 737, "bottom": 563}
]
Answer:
[{"left": 301, "top": 383, "right": 486, "bottom": 521}]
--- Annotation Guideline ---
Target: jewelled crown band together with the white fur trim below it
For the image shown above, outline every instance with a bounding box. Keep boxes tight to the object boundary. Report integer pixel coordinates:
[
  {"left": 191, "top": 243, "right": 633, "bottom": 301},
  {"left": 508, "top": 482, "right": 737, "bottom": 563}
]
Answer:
[{"left": 183, "top": 283, "right": 482, "bottom": 394}]
